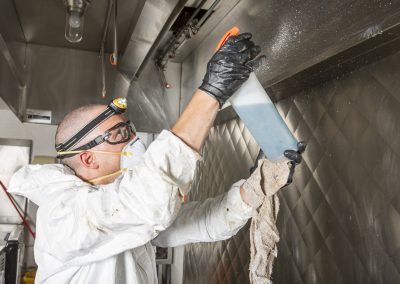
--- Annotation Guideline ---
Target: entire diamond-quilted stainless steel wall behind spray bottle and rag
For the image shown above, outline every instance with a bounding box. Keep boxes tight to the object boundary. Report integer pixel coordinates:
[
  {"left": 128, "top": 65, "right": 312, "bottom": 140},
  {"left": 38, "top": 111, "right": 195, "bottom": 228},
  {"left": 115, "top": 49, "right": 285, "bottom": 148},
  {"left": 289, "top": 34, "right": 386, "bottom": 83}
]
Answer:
[{"left": 184, "top": 50, "right": 400, "bottom": 284}]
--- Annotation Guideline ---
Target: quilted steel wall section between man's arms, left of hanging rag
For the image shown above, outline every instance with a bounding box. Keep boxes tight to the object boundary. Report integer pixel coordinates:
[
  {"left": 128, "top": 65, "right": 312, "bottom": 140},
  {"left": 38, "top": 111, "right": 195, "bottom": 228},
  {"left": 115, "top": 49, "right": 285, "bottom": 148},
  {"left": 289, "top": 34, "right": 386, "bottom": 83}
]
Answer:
[{"left": 183, "top": 119, "right": 259, "bottom": 283}]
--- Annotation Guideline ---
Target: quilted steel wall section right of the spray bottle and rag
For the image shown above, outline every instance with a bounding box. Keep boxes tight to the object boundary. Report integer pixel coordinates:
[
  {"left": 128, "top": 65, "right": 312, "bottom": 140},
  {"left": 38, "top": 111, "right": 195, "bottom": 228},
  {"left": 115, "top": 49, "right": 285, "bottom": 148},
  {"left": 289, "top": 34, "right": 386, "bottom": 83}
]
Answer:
[{"left": 275, "top": 50, "right": 400, "bottom": 284}]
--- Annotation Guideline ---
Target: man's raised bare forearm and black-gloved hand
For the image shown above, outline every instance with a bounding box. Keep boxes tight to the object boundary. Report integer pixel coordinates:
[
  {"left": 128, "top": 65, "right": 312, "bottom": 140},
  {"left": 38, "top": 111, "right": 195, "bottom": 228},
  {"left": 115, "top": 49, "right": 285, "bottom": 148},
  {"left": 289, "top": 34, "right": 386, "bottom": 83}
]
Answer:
[{"left": 171, "top": 33, "right": 262, "bottom": 151}]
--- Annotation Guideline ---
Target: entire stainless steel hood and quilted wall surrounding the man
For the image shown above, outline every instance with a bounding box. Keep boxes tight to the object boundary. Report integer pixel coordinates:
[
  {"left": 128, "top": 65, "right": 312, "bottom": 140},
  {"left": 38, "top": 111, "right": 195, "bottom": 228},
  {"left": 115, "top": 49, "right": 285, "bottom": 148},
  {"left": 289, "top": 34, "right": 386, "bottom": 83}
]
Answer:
[{"left": 0, "top": 0, "right": 400, "bottom": 284}]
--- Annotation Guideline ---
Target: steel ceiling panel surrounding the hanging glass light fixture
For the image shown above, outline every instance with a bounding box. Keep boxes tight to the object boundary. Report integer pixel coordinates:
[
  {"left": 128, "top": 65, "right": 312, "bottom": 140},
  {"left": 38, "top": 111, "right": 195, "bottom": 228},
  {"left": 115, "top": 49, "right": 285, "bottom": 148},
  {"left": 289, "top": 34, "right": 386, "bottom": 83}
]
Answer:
[{"left": 12, "top": 0, "right": 145, "bottom": 52}]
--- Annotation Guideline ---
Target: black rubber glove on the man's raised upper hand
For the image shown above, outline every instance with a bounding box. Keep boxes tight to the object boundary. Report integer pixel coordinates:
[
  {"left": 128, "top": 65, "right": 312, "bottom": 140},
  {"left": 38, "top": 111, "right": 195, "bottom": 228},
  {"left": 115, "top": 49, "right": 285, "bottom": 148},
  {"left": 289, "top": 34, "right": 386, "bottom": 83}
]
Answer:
[{"left": 199, "top": 33, "right": 265, "bottom": 107}]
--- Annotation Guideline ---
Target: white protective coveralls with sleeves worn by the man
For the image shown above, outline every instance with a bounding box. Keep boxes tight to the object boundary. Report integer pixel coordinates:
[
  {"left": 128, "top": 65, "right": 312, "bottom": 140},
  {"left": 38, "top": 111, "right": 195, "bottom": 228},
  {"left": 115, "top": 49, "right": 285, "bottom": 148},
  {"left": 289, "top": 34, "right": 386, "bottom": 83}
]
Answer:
[{"left": 9, "top": 131, "right": 252, "bottom": 284}]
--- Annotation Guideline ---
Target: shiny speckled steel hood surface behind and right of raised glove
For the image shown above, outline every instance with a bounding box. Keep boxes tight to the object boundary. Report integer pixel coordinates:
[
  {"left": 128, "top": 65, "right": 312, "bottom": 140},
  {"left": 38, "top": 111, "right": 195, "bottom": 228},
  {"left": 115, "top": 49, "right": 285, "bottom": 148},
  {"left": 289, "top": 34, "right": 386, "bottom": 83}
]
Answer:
[{"left": 180, "top": 0, "right": 400, "bottom": 108}]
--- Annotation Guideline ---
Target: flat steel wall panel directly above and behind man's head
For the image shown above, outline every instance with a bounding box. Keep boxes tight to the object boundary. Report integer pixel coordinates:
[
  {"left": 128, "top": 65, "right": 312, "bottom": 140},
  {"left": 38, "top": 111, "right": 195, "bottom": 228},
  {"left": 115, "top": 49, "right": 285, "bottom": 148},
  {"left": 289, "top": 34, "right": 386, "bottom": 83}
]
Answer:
[{"left": 26, "top": 44, "right": 129, "bottom": 124}]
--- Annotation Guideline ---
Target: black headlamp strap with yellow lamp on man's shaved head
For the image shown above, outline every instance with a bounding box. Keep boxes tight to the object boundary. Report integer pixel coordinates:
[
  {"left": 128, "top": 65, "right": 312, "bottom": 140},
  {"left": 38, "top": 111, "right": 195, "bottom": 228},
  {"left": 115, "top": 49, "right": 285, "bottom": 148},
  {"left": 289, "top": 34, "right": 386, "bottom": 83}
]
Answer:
[{"left": 56, "top": 98, "right": 126, "bottom": 152}]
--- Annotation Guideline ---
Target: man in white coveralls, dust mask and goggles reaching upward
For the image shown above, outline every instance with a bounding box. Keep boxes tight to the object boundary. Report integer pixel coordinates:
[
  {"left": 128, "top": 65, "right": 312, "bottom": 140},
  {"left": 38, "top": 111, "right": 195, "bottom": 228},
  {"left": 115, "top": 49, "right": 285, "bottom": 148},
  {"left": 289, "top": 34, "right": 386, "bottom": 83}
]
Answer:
[{"left": 10, "top": 33, "right": 288, "bottom": 284}]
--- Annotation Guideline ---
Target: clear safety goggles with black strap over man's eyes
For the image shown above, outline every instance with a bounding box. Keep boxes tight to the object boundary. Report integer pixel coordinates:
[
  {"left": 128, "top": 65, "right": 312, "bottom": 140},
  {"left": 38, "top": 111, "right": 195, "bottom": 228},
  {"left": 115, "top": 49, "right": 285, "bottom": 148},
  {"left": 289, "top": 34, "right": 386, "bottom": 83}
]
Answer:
[{"left": 57, "top": 121, "right": 136, "bottom": 159}]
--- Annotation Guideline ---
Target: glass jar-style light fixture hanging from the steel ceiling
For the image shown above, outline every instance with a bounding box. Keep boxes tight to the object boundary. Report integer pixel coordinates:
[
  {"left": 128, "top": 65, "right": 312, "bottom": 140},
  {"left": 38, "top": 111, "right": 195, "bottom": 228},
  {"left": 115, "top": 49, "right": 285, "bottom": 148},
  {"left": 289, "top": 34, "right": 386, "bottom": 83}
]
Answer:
[{"left": 64, "top": 0, "right": 90, "bottom": 43}]
